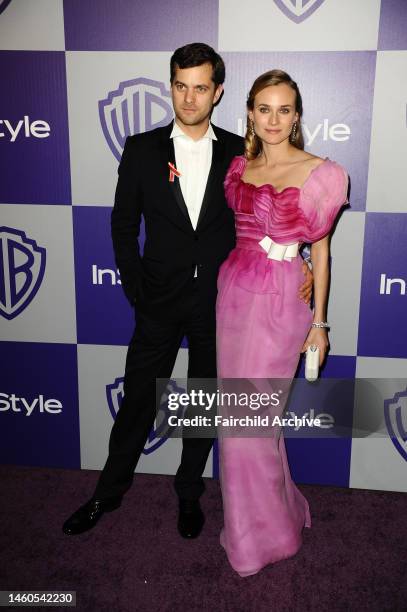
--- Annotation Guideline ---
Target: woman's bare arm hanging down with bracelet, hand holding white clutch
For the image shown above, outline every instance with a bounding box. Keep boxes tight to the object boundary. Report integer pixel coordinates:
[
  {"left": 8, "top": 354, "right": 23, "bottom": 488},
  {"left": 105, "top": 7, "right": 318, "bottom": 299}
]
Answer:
[{"left": 301, "top": 236, "right": 329, "bottom": 365}]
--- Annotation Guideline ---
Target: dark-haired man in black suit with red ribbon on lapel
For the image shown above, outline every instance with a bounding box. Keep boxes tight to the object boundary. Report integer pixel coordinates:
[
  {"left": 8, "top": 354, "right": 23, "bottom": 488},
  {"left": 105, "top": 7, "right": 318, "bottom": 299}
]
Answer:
[{"left": 63, "top": 43, "right": 310, "bottom": 538}]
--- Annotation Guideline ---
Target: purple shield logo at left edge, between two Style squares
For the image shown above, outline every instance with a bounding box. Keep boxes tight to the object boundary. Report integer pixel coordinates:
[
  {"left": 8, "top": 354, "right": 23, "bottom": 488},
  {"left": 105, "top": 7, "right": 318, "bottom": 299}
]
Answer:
[{"left": 0, "top": 226, "right": 46, "bottom": 320}]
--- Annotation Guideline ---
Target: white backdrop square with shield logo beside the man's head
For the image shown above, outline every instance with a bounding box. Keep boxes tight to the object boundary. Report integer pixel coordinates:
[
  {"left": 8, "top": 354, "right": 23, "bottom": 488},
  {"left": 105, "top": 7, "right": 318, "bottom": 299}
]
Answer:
[{"left": 66, "top": 51, "right": 172, "bottom": 206}]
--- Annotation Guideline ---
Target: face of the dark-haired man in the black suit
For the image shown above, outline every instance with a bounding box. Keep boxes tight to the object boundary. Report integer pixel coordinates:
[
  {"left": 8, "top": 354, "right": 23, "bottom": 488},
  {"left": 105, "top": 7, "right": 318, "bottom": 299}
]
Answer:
[{"left": 171, "top": 63, "right": 223, "bottom": 127}]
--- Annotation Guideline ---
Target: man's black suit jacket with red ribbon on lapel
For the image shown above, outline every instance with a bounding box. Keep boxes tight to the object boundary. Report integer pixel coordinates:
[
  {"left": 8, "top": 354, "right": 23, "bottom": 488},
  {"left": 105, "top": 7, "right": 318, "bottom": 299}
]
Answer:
[{"left": 112, "top": 123, "right": 243, "bottom": 316}]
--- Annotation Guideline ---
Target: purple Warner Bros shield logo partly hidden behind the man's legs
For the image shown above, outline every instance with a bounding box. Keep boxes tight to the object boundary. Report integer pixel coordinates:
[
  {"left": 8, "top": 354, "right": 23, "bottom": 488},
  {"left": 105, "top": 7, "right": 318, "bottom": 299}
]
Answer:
[{"left": 106, "top": 377, "right": 185, "bottom": 455}]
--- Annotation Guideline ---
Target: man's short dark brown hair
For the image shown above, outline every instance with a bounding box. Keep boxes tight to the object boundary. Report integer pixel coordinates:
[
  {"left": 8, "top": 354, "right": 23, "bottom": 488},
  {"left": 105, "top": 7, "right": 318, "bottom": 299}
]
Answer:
[{"left": 170, "top": 43, "right": 225, "bottom": 87}]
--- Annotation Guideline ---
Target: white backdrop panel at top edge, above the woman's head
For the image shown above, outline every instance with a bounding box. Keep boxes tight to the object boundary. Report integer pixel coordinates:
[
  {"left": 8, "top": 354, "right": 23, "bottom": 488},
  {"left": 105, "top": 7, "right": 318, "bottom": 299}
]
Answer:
[{"left": 219, "top": 0, "right": 380, "bottom": 51}]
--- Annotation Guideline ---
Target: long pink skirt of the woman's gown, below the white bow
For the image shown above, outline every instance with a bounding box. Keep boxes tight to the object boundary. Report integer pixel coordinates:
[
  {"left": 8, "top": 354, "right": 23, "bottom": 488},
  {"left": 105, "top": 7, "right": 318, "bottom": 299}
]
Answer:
[{"left": 217, "top": 241, "right": 312, "bottom": 576}]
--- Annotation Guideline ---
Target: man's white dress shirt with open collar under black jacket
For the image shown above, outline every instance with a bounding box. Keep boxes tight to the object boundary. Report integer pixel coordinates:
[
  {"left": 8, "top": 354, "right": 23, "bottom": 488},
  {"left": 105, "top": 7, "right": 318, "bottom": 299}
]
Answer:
[{"left": 171, "top": 121, "right": 217, "bottom": 229}]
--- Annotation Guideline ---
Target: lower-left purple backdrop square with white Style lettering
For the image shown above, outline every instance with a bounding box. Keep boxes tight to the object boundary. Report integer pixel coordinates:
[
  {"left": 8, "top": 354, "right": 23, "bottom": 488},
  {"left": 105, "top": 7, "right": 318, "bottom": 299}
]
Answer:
[{"left": 0, "top": 342, "right": 80, "bottom": 468}]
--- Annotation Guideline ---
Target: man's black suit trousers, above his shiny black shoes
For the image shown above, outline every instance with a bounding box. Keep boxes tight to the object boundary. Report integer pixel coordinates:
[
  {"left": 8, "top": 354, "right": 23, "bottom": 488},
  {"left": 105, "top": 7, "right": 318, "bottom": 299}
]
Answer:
[{"left": 94, "top": 279, "right": 216, "bottom": 500}]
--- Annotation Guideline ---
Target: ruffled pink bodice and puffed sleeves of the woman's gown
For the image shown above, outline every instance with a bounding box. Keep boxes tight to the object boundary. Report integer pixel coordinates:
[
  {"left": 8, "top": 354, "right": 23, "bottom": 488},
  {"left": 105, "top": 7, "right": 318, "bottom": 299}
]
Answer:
[{"left": 224, "top": 156, "right": 348, "bottom": 244}]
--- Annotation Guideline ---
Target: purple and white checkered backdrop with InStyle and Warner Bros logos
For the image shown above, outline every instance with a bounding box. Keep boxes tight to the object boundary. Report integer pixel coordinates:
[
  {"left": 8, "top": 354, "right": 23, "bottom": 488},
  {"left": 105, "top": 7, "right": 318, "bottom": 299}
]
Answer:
[{"left": 0, "top": 0, "right": 407, "bottom": 490}]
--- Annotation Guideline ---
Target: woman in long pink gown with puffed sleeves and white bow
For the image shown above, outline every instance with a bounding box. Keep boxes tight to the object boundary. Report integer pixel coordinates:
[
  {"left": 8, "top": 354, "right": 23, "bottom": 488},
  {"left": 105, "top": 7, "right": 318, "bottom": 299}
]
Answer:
[{"left": 217, "top": 70, "right": 348, "bottom": 576}]
